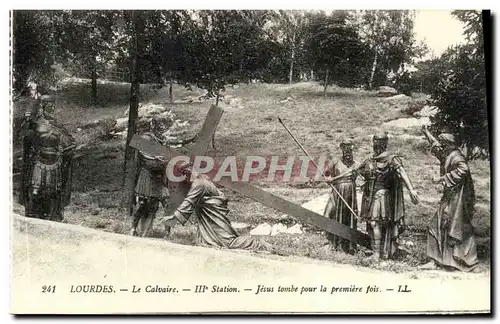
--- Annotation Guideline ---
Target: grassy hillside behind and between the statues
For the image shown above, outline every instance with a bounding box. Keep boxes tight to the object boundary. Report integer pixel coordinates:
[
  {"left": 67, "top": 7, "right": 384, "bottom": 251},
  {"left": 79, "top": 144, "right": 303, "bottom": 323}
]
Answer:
[{"left": 10, "top": 79, "right": 490, "bottom": 271}]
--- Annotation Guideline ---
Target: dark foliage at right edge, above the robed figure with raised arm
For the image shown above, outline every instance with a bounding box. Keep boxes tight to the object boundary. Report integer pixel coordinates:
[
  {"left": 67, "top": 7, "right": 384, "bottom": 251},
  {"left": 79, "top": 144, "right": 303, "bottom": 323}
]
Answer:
[{"left": 430, "top": 11, "right": 489, "bottom": 157}]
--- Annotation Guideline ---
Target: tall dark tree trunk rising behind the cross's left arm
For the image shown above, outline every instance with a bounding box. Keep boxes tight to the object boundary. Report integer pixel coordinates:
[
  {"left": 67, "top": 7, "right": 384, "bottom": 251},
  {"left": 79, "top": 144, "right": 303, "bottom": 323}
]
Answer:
[{"left": 123, "top": 11, "right": 144, "bottom": 198}]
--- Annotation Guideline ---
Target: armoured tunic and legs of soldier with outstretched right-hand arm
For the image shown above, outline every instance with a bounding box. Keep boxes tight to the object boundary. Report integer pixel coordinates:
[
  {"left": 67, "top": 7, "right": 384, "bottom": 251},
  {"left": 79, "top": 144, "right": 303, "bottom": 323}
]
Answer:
[{"left": 359, "top": 151, "right": 405, "bottom": 258}]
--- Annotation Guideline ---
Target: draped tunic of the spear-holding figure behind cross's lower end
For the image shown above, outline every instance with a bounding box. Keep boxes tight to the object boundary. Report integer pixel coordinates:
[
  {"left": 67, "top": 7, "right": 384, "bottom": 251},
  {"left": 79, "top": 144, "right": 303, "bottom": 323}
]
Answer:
[{"left": 324, "top": 160, "right": 359, "bottom": 252}]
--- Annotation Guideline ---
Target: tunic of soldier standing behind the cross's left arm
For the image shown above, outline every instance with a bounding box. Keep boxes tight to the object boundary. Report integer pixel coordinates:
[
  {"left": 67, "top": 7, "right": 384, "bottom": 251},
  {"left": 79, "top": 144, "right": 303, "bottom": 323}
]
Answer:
[{"left": 134, "top": 133, "right": 169, "bottom": 225}]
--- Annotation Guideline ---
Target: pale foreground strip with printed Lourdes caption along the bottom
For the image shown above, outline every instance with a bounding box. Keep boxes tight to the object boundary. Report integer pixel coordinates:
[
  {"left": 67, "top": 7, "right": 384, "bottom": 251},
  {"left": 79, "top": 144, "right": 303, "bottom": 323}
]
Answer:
[{"left": 11, "top": 215, "right": 490, "bottom": 313}]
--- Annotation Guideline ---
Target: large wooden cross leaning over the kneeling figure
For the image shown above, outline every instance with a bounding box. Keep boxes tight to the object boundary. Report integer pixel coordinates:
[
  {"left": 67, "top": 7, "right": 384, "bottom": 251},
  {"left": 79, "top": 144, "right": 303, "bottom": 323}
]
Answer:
[{"left": 130, "top": 106, "right": 371, "bottom": 248}]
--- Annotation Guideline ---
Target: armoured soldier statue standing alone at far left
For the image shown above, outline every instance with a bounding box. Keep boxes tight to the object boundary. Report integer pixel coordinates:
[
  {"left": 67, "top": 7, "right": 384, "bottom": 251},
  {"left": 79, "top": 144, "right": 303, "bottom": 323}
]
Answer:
[{"left": 19, "top": 95, "right": 76, "bottom": 222}]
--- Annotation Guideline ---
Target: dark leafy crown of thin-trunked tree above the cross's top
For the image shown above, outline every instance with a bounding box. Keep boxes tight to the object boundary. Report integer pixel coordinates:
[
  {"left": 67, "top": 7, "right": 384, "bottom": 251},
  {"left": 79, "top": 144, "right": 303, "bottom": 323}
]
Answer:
[{"left": 175, "top": 10, "right": 278, "bottom": 95}]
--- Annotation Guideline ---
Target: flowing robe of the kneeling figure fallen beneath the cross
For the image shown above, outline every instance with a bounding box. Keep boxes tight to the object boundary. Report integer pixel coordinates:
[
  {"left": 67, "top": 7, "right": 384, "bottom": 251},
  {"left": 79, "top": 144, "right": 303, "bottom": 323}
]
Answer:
[{"left": 174, "top": 178, "right": 270, "bottom": 250}]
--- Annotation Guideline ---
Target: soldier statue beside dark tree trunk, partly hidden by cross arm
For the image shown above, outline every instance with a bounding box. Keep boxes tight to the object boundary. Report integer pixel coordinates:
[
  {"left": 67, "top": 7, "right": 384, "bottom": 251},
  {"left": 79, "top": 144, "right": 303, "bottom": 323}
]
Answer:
[{"left": 129, "top": 118, "right": 170, "bottom": 237}]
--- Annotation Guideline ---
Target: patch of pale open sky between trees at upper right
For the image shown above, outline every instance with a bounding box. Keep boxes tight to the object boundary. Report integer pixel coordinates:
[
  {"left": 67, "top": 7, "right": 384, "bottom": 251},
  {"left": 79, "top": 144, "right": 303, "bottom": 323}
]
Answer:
[{"left": 414, "top": 10, "right": 465, "bottom": 58}]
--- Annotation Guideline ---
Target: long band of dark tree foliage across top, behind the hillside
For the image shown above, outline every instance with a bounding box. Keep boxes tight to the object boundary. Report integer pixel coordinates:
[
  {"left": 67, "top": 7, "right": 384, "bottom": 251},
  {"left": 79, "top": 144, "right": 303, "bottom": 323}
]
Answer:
[{"left": 14, "top": 10, "right": 430, "bottom": 95}]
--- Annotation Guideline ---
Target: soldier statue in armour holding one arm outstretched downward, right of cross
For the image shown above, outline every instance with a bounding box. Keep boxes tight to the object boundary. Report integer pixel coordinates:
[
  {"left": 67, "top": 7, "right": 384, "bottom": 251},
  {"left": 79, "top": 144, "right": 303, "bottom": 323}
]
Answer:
[{"left": 358, "top": 133, "right": 419, "bottom": 260}]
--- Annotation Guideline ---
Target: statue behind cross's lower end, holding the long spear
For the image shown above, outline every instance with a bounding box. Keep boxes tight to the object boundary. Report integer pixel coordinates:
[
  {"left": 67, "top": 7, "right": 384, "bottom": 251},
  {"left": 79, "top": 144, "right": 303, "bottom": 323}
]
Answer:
[{"left": 324, "top": 139, "right": 359, "bottom": 253}]
